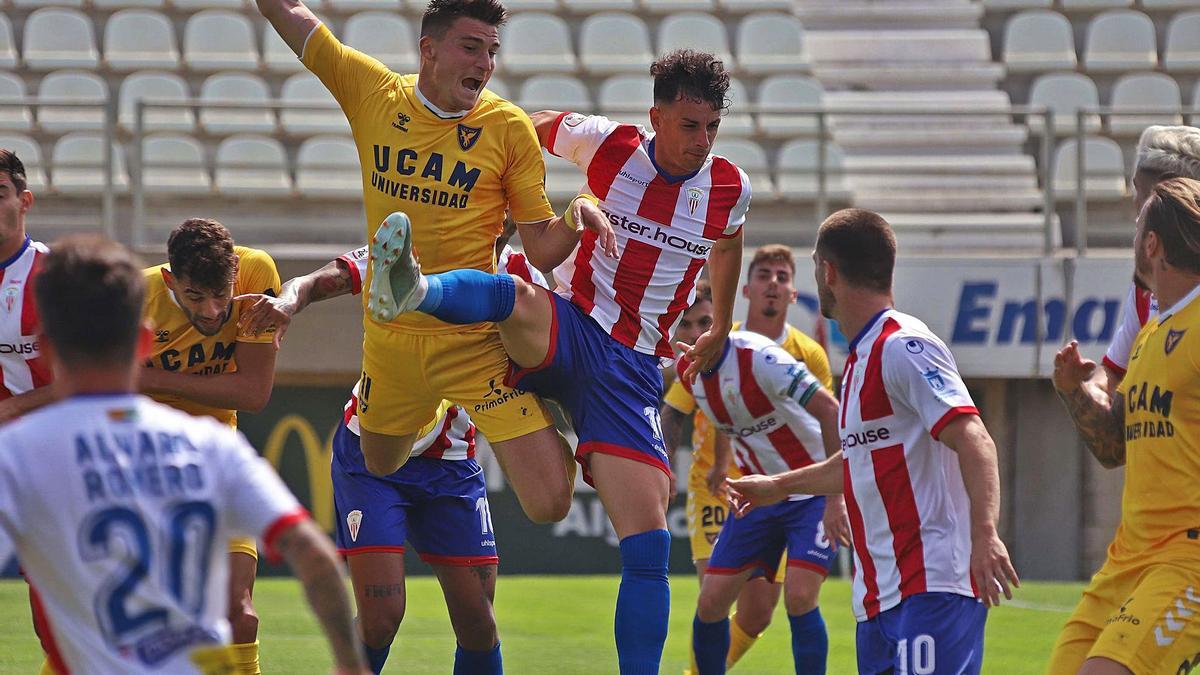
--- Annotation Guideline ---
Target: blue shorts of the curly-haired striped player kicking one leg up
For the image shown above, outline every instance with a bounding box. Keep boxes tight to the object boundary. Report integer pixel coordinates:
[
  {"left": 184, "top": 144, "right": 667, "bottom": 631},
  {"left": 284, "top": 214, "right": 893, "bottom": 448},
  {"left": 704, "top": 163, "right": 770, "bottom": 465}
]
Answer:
[{"left": 505, "top": 293, "right": 671, "bottom": 485}]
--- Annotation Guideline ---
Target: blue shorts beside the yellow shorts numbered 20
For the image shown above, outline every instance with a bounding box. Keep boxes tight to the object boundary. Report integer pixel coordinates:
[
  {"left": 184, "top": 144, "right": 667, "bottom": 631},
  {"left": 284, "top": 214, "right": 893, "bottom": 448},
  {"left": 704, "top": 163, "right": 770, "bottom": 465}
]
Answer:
[{"left": 706, "top": 497, "right": 833, "bottom": 581}]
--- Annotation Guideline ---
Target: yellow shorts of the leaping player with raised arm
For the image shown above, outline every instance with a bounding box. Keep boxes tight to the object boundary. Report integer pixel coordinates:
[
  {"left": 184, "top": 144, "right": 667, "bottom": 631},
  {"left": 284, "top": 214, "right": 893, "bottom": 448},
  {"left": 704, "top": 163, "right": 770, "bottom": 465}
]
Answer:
[{"left": 359, "top": 322, "right": 552, "bottom": 443}]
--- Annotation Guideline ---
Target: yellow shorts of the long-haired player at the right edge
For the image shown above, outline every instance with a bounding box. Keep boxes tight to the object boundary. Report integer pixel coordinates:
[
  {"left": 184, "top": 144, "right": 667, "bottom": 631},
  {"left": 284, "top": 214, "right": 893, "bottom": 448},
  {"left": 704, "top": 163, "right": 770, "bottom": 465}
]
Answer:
[{"left": 1046, "top": 554, "right": 1200, "bottom": 675}]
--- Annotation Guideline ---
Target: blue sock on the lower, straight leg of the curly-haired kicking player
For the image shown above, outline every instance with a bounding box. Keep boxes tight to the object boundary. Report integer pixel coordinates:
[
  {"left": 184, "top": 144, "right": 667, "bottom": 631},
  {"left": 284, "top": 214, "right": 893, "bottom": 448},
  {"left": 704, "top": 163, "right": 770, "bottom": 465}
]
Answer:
[{"left": 616, "top": 530, "right": 671, "bottom": 675}]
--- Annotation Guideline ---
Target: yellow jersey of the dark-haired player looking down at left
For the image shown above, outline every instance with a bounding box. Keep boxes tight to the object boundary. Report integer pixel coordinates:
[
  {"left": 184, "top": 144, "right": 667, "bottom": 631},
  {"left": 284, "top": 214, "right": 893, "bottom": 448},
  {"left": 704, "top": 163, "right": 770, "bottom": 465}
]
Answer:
[{"left": 142, "top": 246, "right": 280, "bottom": 428}]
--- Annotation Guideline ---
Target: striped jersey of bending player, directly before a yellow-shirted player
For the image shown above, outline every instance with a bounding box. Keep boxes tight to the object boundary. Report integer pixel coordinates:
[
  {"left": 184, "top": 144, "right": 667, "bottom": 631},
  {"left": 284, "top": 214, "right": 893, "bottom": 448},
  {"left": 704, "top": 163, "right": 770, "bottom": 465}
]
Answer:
[{"left": 676, "top": 330, "right": 826, "bottom": 500}]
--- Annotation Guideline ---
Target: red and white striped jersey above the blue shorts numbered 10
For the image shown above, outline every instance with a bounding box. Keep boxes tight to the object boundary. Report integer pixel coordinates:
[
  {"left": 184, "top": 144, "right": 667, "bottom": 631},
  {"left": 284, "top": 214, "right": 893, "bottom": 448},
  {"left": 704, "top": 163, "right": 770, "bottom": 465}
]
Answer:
[{"left": 840, "top": 309, "right": 978, "bottom": 621}]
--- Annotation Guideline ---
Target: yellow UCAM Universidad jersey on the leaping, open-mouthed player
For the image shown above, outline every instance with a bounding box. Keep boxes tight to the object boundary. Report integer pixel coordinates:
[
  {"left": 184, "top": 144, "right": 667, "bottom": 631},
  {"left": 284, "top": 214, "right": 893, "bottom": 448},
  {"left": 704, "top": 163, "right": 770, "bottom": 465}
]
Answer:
[{"left": 301, "top": 25, "right": 554, "bottom": 334}]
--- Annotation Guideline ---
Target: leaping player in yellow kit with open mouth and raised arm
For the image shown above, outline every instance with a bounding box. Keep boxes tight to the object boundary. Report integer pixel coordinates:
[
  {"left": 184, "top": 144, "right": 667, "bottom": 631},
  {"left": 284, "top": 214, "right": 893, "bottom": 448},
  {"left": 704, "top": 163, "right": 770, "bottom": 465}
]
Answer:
[{"left": 258, "top": 0, "right": 614, "bottom": 522}]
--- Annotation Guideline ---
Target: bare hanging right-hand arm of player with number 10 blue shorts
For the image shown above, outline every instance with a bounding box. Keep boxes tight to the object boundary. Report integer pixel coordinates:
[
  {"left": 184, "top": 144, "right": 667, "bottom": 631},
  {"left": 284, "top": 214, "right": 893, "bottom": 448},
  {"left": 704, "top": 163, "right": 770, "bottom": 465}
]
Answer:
[{"left": 937, "top": 414, "right": 1021, "bottom": 607}]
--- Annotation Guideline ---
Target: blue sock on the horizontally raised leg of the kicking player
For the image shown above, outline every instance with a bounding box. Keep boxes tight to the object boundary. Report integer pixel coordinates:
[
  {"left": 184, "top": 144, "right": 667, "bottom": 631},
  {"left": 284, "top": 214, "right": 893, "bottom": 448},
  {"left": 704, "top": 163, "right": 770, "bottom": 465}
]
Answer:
[{"left": 416, "top": 269, "right": 517, "bottom": 324}]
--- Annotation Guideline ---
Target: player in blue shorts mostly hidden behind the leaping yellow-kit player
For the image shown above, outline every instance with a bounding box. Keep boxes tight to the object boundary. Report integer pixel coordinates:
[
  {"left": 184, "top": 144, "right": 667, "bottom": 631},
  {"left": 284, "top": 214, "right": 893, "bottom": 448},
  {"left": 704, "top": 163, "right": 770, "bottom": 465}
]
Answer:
[{"left": 238, "top": 223, "right": 546, "bottom": 674}]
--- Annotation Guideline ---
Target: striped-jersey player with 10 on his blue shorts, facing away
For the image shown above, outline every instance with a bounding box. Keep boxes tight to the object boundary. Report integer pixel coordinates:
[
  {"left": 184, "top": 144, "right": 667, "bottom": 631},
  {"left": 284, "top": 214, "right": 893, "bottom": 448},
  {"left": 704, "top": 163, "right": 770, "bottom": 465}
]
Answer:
[{"left": 730, "top": 209, "right": 1019, "bottom": 674}]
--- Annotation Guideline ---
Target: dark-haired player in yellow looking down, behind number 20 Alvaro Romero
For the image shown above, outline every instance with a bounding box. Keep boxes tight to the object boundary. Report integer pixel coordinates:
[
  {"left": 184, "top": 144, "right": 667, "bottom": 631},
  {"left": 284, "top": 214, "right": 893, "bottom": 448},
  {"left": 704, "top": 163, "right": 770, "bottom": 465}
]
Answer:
[{"left": 138, "top": 219, "right": 280, "bottom": 673}]
